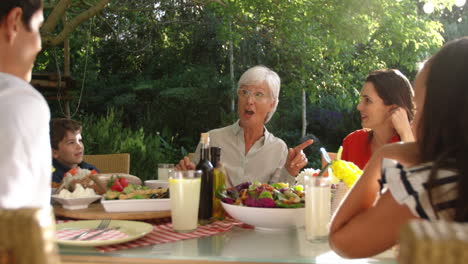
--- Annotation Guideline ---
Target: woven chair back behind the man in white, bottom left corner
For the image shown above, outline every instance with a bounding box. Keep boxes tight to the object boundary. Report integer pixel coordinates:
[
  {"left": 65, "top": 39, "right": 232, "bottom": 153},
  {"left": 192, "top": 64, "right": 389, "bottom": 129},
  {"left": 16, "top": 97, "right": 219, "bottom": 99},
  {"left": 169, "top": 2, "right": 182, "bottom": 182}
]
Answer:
[{"left": 0, "top": 208, "right": 60, "bottom": 264}]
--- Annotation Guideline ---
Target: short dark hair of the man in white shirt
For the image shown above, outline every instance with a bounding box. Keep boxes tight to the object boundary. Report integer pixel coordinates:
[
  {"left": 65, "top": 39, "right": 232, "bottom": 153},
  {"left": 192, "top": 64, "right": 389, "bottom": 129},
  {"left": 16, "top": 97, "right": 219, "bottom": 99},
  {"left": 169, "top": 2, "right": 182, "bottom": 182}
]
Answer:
[{"left": 0, "top": 0, "right": 42, "bottom": 29}]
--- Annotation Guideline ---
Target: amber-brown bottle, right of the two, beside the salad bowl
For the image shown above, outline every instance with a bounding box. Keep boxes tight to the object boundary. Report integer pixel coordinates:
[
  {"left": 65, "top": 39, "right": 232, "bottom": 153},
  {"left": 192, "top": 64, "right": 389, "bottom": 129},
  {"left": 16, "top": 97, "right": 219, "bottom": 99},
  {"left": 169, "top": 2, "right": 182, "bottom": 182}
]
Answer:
[{"left": 210, "top": 147, "right": 226, "bottom": 220}]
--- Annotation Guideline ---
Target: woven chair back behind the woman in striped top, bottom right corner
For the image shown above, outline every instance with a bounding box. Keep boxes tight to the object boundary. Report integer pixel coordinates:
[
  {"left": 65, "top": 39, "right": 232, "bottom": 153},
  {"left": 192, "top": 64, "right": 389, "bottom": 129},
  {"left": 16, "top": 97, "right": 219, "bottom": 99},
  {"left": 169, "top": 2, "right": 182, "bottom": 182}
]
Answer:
[{"left": 399, "top": 220, "right": 468, "bottom": 264}]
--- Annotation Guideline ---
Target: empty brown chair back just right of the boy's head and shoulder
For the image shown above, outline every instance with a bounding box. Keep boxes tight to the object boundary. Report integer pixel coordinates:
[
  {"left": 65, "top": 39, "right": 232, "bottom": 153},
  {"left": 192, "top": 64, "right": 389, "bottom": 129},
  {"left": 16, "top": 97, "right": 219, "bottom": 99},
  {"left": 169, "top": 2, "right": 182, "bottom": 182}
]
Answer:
[{"left": 83, "top": 153, "right": 130, "bottom": 174}]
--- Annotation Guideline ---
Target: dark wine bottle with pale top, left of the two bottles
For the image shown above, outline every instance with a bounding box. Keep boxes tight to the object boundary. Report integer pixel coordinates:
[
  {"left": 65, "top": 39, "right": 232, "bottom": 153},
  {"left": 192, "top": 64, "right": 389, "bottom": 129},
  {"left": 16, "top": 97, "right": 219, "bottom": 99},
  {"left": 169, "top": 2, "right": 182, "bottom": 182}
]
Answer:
[{"left": 196, "top": 133, "right": 213, "bottom": 225}]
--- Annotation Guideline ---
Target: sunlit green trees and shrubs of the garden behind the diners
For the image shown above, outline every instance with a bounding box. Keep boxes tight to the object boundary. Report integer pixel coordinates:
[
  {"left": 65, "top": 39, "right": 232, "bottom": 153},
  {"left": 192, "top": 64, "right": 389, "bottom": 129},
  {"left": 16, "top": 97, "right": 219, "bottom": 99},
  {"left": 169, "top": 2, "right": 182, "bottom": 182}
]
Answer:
[{"left": 34, "top": 0, "right": 468, "bottom": 179}]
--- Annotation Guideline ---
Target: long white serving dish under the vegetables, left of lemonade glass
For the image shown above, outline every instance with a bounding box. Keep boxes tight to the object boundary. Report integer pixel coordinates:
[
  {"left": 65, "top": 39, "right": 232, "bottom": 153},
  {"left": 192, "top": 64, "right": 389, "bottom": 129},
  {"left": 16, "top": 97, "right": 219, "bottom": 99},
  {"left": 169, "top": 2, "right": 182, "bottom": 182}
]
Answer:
[{"left": 101, "top": 197, "right": 171, "bottom": 213}]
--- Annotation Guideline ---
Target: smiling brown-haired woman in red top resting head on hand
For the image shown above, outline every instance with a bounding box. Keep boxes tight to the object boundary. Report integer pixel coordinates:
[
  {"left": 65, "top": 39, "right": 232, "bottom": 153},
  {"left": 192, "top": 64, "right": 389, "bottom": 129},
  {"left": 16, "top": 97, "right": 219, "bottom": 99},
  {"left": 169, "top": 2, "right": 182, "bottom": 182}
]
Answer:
[{"left": 341, "top": 69, "right": 414, "bottom": 169}]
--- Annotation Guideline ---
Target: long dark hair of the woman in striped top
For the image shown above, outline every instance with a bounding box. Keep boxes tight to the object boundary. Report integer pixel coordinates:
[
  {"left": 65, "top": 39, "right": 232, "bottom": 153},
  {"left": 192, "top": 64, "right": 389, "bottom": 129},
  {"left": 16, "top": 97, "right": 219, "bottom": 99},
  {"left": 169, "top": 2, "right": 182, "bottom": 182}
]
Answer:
[{"left": 417, "top": 37, "right": 468, "bottom": 222}]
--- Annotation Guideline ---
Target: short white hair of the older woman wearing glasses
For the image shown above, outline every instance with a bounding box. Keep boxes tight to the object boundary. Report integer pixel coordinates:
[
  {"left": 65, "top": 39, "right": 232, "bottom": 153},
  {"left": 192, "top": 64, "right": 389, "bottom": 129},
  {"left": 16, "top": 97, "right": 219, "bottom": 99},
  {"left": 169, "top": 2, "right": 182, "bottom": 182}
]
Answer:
[{"left": 237, "top": 65, "right": 281, "bottom": 124}]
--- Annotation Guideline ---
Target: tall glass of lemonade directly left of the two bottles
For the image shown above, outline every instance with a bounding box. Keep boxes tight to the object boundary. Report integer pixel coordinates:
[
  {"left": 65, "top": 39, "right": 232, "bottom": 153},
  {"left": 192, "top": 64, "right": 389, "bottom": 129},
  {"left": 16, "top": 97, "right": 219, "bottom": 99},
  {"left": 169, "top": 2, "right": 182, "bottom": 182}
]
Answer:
[{"left": 169, "top": 170, "right": 202, "bottom": 233}]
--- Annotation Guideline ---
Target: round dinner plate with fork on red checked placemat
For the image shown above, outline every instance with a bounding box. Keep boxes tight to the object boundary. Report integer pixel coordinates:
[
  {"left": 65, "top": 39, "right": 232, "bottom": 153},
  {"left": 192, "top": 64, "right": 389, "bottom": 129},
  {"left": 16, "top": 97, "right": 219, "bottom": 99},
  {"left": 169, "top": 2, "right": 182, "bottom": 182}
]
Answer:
[{"left": 56, "top": 220, "right": 153, "bottom": 247}]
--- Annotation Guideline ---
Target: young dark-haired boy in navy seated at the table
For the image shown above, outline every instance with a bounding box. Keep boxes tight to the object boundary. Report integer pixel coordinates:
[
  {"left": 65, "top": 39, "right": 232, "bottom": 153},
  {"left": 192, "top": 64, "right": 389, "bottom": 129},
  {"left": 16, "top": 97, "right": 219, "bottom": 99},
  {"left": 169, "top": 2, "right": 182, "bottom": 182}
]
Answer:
[{"left": 50, "top": 118, "right": 99, "bottom": 183}]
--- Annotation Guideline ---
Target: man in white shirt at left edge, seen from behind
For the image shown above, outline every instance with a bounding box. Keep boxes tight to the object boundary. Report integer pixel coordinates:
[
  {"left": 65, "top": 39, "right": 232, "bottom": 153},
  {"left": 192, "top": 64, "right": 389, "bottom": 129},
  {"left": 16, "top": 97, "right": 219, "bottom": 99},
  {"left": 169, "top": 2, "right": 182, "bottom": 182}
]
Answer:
[{"left": 0, "top": 0, "right": 51, "bottom": 209}]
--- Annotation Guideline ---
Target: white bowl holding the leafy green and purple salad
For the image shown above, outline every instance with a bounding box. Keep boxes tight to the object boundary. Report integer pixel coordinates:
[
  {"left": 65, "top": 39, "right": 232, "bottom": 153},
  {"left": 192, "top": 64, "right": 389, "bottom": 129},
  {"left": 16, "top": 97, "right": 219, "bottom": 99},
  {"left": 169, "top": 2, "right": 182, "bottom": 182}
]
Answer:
[{"left": 221, "top": 202, "right": 305, "bottom": 231}]
